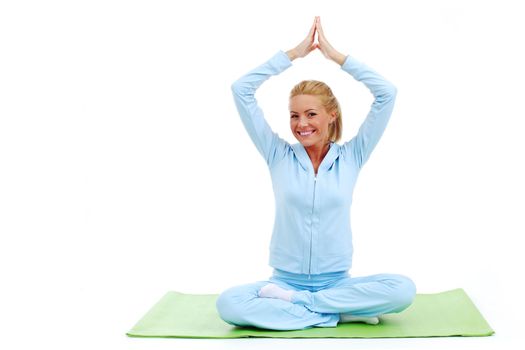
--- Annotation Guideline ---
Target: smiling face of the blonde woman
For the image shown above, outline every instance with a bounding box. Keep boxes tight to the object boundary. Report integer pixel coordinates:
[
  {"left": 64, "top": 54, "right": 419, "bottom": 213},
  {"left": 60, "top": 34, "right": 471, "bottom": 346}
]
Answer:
[{"left": 289, "top": 95, "right": 335, "bottom": 147}]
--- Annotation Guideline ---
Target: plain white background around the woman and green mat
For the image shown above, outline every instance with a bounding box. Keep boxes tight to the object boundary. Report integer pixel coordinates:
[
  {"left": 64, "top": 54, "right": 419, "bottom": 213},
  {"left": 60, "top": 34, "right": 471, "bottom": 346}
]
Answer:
[{"left": 0, "top": 0, "right": 525, "bottom": 349}]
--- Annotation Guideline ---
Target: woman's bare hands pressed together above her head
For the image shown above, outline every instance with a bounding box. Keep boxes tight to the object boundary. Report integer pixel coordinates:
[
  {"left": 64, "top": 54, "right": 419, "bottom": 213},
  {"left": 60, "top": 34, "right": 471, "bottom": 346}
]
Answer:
[{"left": 286, "top": 16, "right": 346, "bottom": 65}]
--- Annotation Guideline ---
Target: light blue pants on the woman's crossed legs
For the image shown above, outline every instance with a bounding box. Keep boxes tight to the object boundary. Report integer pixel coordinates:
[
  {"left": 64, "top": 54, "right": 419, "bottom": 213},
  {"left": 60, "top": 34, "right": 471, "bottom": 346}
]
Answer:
[{"left": 216, "top": 269, "right": 416, "bottom": 330}]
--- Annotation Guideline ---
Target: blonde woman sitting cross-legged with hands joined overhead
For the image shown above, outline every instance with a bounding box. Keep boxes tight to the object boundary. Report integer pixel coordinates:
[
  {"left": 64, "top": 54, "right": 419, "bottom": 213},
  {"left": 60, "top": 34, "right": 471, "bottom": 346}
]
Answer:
[{"left": 216, "top": 17, "right": 416, "bottom": 330}]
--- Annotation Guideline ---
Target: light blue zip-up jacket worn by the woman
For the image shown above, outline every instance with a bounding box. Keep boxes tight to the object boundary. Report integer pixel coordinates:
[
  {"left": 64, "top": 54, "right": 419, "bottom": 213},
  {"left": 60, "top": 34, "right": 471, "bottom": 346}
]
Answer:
[{"left": 231, "top": 50, "right": 397, "bottom": 275}]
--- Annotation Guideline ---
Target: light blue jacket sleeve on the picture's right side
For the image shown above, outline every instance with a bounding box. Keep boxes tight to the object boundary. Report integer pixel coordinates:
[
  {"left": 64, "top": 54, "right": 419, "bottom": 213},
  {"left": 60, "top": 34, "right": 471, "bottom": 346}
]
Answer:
[{"left": 341, "top": 55, "right": 397, "bottom": 168}]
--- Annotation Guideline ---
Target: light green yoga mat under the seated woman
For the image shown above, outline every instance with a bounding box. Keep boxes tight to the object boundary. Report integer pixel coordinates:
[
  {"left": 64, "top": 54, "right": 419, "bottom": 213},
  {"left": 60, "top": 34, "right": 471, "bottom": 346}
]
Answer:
[{"left": 126, "top": 289, "right": 494, "bottom": 338}]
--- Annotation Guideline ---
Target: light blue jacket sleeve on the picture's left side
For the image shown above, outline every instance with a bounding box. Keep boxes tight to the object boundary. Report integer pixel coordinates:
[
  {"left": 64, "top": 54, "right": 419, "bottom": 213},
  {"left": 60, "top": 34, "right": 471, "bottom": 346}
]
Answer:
[{"left": 231, "top": 50, "right": 292, "bottom": 167}]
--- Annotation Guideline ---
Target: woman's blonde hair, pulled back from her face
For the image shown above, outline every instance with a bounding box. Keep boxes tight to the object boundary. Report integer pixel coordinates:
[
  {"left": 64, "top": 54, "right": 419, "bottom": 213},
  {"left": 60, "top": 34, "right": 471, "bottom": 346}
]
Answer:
[{"left": 290, "top": 80, "right": 343, "bottom": 142}]
